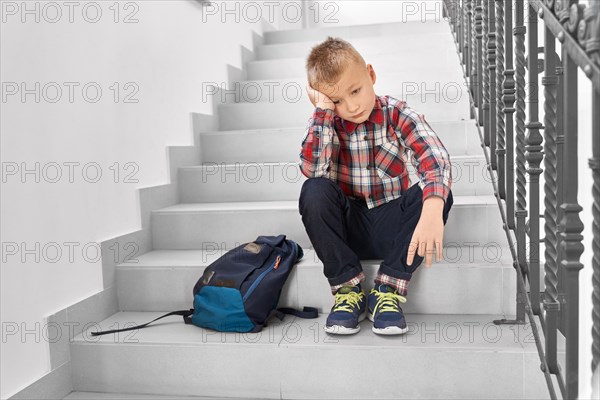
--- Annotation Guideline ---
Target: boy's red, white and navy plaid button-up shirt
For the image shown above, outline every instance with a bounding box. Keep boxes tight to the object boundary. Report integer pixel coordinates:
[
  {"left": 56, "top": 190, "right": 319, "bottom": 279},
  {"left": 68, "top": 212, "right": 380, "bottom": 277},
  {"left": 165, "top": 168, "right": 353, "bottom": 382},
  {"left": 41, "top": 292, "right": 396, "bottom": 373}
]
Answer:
[{"left": 300, "top": 96, "right": 452, "bottom": 208}]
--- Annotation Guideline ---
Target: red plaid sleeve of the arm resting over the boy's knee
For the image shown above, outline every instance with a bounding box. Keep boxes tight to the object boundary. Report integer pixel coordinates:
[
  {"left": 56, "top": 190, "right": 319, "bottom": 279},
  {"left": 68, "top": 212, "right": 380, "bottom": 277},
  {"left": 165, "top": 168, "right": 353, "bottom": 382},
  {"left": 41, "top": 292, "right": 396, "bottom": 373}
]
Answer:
[{"left": 392, "top": 107, "right": 452, "bottom": 202}]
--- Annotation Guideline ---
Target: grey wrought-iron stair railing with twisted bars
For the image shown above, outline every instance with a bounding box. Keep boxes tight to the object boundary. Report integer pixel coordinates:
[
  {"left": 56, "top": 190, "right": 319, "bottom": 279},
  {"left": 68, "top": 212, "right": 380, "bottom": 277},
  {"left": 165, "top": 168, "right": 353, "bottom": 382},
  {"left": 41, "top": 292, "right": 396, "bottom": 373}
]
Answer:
[{"left": 444, "top": 0, "right": 600, "bottom": 399}]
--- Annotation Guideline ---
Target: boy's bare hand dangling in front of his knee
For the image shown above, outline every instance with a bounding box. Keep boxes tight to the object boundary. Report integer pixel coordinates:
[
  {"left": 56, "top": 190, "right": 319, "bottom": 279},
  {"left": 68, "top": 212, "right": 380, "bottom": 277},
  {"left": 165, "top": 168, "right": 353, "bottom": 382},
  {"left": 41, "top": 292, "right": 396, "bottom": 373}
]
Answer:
[{"left": 406, "top": 196, "right": 444, "bottom": 267}]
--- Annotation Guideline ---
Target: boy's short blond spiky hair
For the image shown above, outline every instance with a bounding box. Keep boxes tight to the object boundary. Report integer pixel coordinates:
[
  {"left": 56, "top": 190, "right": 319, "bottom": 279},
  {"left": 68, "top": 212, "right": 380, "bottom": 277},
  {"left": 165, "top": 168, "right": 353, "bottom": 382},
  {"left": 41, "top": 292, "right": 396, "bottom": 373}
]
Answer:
[{"left": 306, "top": 36, "right": 366, "bottom": 89}]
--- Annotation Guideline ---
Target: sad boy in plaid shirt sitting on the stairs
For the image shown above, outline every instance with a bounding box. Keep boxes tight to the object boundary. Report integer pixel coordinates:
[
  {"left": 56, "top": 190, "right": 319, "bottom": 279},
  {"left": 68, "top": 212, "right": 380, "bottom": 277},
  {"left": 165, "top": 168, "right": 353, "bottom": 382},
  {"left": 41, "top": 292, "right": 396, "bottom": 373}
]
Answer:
[{"left": 299, "top": 37, "right": 453, "bottom": 335}]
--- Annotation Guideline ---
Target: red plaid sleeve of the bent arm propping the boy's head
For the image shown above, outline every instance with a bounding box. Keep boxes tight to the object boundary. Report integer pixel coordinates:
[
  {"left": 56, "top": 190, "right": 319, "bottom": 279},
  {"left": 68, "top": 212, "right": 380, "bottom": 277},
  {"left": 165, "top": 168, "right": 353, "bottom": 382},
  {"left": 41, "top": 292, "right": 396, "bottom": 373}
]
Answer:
[{"left": 300, "top": 107, "right": 335, "bottom": 178}]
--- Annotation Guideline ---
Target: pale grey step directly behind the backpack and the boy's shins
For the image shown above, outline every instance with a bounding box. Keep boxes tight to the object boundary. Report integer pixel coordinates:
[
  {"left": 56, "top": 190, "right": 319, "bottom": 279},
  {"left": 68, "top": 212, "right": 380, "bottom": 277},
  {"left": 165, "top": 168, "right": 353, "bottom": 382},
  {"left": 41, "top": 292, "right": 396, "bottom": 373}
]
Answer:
[{"left": 116, "top": 244, "right": 516, "bottom": 314}]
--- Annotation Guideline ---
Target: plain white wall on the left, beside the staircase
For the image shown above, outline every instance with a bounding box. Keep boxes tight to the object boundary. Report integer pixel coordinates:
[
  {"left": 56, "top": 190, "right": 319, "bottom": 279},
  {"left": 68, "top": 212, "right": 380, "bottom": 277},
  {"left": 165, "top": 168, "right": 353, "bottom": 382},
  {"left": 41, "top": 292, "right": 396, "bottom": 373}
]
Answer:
[{"left": 0, "top": 0, "right": 294, "bottom": 398}]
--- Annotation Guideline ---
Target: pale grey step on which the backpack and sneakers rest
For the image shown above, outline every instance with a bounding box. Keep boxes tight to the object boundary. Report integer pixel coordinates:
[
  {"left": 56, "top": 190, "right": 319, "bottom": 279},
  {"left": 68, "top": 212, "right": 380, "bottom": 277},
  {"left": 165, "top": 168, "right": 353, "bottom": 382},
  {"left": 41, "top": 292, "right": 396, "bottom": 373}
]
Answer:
[{"left": 71, "top": 312, "right": 547, "bottom": 399}]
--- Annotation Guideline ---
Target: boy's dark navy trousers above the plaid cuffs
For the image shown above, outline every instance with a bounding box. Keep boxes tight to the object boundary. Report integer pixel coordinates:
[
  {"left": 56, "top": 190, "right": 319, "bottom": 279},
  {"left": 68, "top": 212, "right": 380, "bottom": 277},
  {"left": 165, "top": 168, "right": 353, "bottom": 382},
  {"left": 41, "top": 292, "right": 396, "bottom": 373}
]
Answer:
[{"left": 299, "top": 178, "right": 453, "bottom": 286}]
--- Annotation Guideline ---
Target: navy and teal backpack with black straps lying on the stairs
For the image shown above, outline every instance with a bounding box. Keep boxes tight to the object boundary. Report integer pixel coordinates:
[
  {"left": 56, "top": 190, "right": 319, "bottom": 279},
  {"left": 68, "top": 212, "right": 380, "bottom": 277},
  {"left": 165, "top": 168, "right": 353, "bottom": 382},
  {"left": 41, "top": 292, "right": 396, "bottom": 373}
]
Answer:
[{"left": 92, "top": 235, "right": 318, "bottom": 336}]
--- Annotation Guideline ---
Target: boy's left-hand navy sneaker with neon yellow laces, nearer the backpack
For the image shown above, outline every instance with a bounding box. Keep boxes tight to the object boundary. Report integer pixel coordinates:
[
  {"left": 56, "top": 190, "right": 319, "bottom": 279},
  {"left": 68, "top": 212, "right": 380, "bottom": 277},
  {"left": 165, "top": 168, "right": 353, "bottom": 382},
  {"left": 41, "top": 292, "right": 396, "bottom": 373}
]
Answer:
[{"left": 325, "top": 286, "right": 367, "bottom": 335}]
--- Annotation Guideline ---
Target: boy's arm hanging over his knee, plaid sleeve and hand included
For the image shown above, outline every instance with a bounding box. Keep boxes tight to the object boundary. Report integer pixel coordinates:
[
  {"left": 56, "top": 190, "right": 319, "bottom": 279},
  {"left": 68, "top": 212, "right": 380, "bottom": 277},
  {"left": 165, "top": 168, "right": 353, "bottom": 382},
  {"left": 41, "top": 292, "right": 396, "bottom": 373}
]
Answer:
[{"left": 393, "top": 108, "right": 452, "bottom": 267}]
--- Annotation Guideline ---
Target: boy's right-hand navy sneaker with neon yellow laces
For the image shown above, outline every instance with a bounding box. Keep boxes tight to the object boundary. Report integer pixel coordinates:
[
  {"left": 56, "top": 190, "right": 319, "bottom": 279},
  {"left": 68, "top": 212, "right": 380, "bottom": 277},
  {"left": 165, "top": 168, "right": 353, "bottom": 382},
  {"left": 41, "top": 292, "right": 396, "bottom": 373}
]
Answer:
[{"left": 368, "top": 285, "right": 408, "bottom": 335}]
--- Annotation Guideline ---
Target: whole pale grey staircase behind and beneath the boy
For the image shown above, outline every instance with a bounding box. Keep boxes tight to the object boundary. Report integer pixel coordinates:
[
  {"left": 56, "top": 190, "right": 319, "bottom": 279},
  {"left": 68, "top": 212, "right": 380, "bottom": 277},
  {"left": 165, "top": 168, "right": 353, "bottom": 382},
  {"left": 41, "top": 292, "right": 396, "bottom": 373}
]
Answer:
[{"left": 67, "top": 20, "right": 548, "bottom": 399}]
